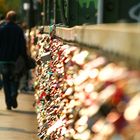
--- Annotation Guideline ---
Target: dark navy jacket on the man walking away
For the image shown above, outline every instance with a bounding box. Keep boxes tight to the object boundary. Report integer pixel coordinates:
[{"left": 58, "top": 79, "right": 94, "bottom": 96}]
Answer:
[{"left": 0, "top": 22, "right": 27, "bottom": 61}]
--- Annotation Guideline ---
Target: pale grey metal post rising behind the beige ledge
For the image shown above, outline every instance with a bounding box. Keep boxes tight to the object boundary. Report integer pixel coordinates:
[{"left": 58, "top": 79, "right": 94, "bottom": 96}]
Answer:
[{"left": 97, "top": 0, "right": 104, "bottom": 24}]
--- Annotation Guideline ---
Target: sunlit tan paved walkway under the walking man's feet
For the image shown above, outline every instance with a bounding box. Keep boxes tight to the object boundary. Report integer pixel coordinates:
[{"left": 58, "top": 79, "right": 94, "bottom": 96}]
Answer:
[{"left": 0, "top": 90, "right": 38, "bottom": 140}]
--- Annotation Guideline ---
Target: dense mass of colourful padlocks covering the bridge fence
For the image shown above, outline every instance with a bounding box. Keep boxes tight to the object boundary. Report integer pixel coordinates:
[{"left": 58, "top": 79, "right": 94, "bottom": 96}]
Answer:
[{"left": 34, "top": 28, "right": 140, "bottom": 140}]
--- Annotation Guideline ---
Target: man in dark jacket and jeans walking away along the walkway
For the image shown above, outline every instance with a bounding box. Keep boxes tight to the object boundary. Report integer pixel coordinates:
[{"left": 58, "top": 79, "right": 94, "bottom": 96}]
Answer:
[{"left": 0, "top": 11, "right": 27, "bottom": 110}]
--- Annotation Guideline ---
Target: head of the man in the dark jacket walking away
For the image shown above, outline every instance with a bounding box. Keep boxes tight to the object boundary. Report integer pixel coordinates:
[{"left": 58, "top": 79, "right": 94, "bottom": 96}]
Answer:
[{"left": 6, "top": 10, "right": 17, "bottom": 22}]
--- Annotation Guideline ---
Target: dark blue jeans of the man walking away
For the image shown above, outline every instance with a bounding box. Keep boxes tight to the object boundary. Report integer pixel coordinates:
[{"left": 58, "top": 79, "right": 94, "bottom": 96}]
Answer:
[{"left": 0, "top": 63, "right": 19, "bottom": 108}]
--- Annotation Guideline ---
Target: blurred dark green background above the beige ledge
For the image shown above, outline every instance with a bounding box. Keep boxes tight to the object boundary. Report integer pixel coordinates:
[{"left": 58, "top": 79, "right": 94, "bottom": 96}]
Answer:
[{"left": 0, "top": 0, "right": 140, "bottom": 27}]
